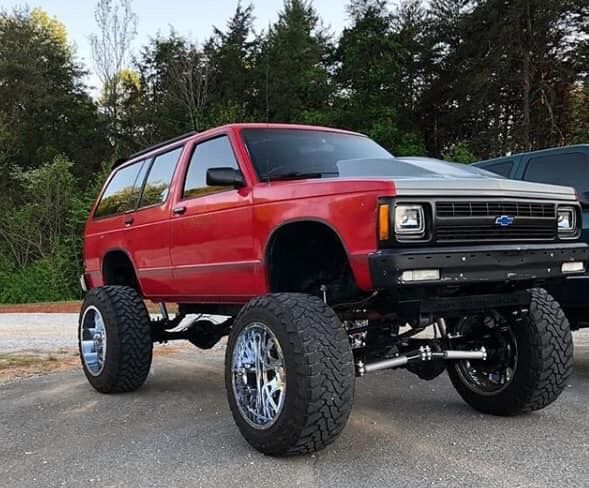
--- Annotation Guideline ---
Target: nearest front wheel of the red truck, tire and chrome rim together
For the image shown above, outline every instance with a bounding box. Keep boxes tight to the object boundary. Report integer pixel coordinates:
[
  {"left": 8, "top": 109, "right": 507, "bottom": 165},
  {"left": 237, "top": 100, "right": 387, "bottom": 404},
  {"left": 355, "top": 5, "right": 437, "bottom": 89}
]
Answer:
[{"left": 225, "top": 293, "right": 354, "bottom": 456}]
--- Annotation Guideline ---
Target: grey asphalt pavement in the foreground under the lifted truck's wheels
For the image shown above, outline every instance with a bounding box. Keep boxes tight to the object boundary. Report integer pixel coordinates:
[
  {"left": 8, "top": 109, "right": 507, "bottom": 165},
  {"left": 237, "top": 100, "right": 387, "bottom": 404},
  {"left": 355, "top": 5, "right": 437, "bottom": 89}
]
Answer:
[{"left": 0, "top": 314, "right": 589, "bottom": 488}]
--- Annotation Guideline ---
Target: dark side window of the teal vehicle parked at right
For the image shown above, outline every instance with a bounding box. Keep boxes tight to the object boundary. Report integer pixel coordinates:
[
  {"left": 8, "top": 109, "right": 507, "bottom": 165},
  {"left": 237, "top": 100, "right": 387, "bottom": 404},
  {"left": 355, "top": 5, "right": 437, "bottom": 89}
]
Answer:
[{"left": 524, "top": 152, "right": 589, "bottom": 194}]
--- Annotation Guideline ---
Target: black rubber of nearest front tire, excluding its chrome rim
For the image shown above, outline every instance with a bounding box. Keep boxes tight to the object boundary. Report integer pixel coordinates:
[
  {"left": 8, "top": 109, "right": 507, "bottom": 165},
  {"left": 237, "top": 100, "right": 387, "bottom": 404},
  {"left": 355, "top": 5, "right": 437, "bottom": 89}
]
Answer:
[{"left": 225, "top": 293, "right": 354, "bottom": 456}]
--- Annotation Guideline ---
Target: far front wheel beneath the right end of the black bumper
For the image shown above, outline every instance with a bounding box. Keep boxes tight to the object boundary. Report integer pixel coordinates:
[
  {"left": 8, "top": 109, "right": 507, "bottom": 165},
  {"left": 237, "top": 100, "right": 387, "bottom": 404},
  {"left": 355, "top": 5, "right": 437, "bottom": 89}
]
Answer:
[{"left": 448, "top": 288, "right": 573, "bottom": 415}]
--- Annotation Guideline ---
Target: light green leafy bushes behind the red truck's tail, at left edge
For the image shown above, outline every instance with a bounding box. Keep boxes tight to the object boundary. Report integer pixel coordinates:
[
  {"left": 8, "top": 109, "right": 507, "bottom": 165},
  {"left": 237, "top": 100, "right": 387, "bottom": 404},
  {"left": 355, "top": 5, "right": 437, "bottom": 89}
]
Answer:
[{"left": 0, "top": 156, "right": 108, "bottom": 303}]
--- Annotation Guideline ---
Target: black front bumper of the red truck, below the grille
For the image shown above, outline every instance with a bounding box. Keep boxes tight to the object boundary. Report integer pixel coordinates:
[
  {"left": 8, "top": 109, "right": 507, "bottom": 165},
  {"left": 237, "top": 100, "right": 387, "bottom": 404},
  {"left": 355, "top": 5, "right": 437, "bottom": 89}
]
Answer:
[{"left": 369, "top": 242, "right": 589, "bottom": 289}]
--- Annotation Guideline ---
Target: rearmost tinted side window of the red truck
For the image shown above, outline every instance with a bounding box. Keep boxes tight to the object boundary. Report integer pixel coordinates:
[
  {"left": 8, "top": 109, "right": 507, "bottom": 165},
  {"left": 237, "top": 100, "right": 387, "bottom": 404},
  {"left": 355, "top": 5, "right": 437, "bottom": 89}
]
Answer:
[{"left": 94, "top": 161, "right": 147, "bottom": 217}]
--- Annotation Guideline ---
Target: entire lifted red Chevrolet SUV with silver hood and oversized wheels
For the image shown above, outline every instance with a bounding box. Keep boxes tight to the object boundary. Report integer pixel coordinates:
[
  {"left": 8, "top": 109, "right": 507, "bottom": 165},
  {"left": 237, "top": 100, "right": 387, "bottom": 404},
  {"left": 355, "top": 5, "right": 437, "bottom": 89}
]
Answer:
[{"left": 79, "top": 124, "right": 589, "bottom": 455}]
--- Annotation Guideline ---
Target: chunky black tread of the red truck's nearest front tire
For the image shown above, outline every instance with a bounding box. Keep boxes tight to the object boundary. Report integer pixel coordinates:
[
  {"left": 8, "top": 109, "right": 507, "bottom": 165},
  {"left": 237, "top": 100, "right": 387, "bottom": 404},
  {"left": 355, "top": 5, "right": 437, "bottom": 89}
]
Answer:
[{"left": 227, "top": 293, "right": 354, "bottom": 456}]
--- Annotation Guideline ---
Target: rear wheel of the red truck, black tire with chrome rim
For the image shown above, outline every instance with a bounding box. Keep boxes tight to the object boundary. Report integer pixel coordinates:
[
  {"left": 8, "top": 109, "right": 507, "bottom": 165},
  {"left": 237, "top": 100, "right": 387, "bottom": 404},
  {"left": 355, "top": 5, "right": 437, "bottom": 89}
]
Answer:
[{"left": 78, "top": 286, "right": 153, "bottom": 393}]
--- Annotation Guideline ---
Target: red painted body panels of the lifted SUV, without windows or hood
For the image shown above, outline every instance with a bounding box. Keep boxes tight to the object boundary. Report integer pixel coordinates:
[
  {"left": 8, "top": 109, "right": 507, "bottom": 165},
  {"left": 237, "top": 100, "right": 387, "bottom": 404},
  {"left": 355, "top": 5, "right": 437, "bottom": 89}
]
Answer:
[{"left": 84, "top": 124, "right": 395, "bottom": 304}]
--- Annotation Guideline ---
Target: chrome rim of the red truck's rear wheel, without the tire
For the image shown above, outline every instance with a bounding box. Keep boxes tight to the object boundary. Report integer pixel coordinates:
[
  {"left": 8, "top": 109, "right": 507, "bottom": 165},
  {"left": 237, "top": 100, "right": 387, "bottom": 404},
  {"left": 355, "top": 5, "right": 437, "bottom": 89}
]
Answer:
[{"left": 80, "top": 305, "right": 106, "bottom": 376}]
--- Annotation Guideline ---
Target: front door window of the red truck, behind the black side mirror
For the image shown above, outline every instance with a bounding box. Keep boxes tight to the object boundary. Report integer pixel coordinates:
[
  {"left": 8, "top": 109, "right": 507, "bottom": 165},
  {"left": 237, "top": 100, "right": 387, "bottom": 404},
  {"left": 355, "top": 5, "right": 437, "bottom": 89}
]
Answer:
[{"left": 184, "top": 136, "right": 239, "bottom": 198}]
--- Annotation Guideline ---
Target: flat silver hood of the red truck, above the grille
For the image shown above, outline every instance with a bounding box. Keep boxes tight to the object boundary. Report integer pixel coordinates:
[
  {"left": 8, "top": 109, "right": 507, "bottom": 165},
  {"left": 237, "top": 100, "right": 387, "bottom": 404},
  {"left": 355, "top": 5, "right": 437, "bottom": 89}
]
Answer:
[{"left": 394, "top": 176, "right": 577, "bottom": 201}]
